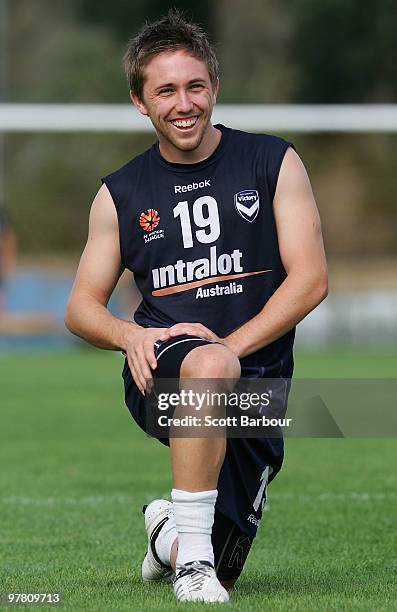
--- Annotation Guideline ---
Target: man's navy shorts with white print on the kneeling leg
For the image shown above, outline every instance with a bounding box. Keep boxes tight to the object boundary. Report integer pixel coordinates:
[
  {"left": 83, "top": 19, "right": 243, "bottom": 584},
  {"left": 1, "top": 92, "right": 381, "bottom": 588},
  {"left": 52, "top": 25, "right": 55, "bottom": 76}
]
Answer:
[{"left": 123, "top": 335, "right": 284, "bottom": 580}]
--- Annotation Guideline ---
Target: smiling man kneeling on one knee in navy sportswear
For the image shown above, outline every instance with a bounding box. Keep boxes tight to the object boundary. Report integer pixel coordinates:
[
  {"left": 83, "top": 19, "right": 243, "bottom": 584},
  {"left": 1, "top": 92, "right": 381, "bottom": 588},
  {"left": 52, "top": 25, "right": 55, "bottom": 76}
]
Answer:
[{"left": 65, "top": 11, "right": 327, "bottom": 602}]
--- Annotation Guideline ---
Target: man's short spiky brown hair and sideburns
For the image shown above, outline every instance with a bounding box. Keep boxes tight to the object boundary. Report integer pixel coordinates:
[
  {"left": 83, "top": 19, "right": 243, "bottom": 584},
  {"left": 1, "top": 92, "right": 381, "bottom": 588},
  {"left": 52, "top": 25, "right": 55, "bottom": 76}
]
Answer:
[{"left": 124, "top": 9, "right": 219, "bottom": 100}]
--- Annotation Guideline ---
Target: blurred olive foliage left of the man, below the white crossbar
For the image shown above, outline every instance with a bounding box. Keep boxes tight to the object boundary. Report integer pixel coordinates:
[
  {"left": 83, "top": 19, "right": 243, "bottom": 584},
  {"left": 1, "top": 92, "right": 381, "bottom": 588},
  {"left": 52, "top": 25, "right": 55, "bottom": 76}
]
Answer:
[{"left": 8, "top": 133, "right": 154, "bottom": 255}]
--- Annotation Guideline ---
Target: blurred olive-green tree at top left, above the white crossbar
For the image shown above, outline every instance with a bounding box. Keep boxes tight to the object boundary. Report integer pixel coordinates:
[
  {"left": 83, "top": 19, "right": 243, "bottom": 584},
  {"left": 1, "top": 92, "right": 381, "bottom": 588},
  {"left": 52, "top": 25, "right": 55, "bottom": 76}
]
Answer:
[{"left": 9, "top": 0, "right": 127, "bottom": 102}]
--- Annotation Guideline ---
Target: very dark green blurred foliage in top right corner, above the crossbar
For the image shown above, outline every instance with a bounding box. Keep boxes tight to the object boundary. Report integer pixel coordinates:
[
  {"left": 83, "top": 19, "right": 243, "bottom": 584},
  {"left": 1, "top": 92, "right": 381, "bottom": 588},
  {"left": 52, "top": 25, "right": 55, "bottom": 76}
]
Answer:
[{"left": 288, "top": 0, "right": 397, "bottom": 103}]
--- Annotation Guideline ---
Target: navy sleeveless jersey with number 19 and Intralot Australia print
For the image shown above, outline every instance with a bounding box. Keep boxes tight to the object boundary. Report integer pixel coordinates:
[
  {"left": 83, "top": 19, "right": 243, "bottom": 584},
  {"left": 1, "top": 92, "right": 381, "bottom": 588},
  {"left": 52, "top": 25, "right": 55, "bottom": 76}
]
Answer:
[{"left": 102, "top": 125, "right": 295, "bottom": 377}]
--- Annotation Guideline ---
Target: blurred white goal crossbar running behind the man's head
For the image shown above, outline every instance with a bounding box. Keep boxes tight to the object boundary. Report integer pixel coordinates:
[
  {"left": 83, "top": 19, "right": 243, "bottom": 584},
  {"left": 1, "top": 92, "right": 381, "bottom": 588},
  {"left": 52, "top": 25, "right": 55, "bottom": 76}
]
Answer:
[{"left": 0, "top": 103, "right": 397, "bottom": 133}]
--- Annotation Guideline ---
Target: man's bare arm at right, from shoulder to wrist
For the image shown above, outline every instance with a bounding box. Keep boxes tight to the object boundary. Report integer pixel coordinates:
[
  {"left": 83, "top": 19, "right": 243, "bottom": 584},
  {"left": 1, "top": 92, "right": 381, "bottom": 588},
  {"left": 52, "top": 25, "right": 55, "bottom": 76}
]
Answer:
[{"left": 223, "top": 148, "right": 328, "bottom": 357}]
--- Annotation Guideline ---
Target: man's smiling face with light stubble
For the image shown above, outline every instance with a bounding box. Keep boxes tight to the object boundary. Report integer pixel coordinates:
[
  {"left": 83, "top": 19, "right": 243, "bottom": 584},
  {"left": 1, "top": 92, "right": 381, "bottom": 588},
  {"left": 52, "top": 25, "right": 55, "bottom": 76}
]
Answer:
[{"left": 131, "top": 50, "right": 218, "bottom": 151}]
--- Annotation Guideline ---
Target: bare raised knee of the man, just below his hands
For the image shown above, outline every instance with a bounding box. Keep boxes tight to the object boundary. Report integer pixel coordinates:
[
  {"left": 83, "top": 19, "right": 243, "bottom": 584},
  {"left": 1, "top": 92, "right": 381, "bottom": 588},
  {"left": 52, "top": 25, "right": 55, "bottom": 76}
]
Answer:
[{"left": 181, "top": 344, "right": 241, "bottom": 379}]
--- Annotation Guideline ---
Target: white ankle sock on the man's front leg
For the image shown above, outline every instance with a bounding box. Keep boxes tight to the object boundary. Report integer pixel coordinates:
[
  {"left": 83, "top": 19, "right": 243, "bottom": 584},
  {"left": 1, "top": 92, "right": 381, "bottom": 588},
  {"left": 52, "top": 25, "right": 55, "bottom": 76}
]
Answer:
[{"left": 171, "top": 489, "right": 218, "bottom": 569}]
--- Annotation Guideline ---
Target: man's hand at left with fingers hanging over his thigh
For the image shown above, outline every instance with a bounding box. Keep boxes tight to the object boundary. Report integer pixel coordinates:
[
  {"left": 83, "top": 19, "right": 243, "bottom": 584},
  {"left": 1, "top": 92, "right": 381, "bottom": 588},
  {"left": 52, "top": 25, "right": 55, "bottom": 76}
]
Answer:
[{"left": 124, "top": 325, "right": 165, "bottom": 395}]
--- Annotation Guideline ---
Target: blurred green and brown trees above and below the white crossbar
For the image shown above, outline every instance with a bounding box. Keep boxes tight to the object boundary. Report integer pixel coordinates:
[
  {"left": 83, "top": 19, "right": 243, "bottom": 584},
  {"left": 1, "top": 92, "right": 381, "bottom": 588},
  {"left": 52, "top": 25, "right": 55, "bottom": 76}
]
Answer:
[{"left": 6, "top": 0, "right": 397, "bottom": 257}]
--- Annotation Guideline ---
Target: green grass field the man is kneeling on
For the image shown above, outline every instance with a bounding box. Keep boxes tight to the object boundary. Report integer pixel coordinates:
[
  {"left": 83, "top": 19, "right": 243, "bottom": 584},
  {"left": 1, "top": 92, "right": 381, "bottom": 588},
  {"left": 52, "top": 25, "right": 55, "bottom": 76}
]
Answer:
[{"left": 0, "top": 350, "right": 397, "bottom": 612}]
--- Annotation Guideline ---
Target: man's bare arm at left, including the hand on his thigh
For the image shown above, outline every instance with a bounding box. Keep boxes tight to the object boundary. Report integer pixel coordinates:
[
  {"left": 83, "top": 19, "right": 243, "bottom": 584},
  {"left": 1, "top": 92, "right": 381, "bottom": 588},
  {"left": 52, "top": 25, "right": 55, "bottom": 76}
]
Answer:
[{"left": 65, "top": 185, "right": 164, "bottom": 392}]
